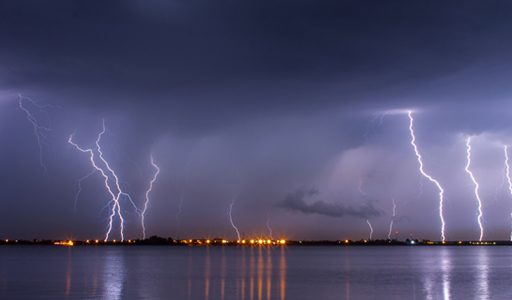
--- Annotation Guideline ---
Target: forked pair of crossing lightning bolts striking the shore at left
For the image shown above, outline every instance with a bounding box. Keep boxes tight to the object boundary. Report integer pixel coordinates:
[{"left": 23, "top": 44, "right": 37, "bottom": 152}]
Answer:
[{"left": 68, "top": 120, "right": 140, "bottom": 242}]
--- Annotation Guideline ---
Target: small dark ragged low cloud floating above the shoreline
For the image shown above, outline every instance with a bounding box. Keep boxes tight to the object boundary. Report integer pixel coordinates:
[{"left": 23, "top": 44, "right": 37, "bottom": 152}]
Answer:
[{"left": 278, "top": 189, "right": 381, "bottom": 219}]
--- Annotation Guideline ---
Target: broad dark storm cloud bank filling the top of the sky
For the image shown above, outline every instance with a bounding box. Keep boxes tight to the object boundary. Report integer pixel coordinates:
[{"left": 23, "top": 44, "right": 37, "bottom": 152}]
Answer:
[{"left": 0, "top": 1, "right": 512, "bottom": 119}]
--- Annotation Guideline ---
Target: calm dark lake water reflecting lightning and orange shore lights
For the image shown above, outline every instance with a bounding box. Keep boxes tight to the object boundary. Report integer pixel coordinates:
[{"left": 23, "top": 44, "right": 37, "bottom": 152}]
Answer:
[{"left": 0, "top": 246, "right": 512, "bottom": 300}]
